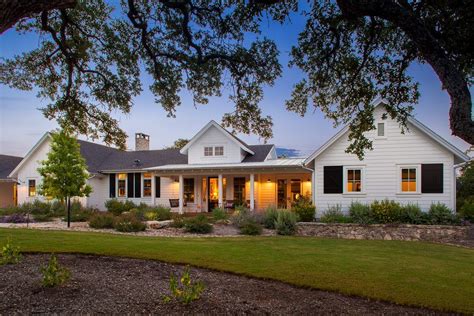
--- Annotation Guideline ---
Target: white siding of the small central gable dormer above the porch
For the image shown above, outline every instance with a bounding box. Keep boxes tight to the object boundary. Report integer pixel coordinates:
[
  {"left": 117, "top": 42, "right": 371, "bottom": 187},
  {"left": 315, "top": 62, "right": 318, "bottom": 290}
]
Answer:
[{"left": 188, "top": 126, "right": 245, "bottom": 164}]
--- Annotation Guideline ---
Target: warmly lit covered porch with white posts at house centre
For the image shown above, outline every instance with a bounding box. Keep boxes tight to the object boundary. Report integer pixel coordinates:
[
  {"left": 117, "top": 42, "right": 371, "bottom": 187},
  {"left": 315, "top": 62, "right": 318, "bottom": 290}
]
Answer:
[{"left": 149, "top": 159, "right": 313, "bottom": 213}]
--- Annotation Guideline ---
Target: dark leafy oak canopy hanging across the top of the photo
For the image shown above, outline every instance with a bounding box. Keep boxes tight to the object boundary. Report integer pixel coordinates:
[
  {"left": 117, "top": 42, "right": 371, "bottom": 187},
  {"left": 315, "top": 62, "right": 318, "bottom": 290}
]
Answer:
[{"left": 0, "top": 0, "right": 474, "bottom": 157}]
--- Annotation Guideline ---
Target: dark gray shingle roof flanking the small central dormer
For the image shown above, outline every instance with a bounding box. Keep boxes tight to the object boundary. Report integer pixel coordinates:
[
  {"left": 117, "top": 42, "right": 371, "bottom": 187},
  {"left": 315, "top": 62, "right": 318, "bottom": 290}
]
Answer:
[{"left": 79, "top": 140, "right": 273, "bottom": 173}]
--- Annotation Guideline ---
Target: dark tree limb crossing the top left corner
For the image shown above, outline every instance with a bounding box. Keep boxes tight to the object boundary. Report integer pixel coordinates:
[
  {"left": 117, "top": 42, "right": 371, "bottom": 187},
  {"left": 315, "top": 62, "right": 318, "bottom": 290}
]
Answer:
[{"left": 0, "top": 0, "right": 77, "bottom": 34}]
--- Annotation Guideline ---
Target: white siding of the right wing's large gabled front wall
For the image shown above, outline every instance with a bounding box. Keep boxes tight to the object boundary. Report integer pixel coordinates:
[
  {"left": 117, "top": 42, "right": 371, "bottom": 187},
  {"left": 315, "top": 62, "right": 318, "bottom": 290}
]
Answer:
[{"left": 312, "top": 107, "right": 455, "bottom": 214}]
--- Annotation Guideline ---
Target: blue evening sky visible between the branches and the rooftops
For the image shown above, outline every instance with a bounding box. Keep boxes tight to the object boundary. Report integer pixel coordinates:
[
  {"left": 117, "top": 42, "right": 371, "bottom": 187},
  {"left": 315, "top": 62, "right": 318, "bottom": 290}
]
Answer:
[{"left": 0, "top": 5, "right": 472, "bottom": 156}]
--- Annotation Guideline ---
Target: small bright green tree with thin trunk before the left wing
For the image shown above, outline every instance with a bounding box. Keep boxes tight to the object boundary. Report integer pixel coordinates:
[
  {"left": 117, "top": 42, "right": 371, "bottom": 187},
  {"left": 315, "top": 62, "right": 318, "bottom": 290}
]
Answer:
[{"left": 38, "top": 129, "right": 92, "bottom": 227}]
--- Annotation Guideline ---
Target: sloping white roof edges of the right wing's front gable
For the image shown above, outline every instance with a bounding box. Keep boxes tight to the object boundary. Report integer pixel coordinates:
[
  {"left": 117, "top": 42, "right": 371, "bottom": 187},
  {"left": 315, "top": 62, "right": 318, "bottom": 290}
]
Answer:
[{"left": 304, "top": 99, "right": 470, "bottom": 165}]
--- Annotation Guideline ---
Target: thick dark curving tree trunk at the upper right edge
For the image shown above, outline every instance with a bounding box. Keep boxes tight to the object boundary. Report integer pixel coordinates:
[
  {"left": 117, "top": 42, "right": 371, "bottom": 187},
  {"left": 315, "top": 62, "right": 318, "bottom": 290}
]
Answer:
[{"left": 337, "top": 0, "right": 474, "bottom": 144}]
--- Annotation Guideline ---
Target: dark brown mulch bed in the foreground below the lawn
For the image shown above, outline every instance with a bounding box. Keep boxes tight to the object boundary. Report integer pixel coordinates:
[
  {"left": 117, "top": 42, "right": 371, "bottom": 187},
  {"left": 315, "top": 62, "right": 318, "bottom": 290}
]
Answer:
[{"left": 0, "top": 254, "right": 452, "bottom": 315}]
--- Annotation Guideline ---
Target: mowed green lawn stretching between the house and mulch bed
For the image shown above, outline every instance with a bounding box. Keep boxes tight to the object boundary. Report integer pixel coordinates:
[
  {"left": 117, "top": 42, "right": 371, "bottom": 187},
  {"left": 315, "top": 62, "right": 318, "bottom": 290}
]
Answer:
[{"left": 0, "top": 229, "right": 474, "bottom": 313}]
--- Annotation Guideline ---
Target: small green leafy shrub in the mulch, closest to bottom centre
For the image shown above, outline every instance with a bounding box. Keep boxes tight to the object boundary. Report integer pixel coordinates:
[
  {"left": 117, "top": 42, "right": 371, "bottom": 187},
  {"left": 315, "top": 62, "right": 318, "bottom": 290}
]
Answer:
[{"left": 163, "top": 267, "right": 205, "bottom": 304}]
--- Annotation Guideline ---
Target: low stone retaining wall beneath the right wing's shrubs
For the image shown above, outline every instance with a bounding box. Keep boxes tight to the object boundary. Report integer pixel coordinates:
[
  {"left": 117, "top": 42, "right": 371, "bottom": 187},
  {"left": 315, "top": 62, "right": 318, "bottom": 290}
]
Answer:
[{"left": 297, "top": 223, "right": 474, "bottom": 243}]
